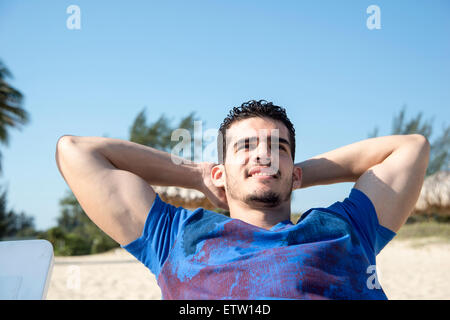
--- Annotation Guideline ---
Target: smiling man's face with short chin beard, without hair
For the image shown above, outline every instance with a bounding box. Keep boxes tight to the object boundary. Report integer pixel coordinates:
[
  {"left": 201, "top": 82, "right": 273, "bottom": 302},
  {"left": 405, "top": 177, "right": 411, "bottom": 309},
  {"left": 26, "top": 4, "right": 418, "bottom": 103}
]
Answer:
[{"left": 224, "top": 117, "right": 298, "bottom": 208}]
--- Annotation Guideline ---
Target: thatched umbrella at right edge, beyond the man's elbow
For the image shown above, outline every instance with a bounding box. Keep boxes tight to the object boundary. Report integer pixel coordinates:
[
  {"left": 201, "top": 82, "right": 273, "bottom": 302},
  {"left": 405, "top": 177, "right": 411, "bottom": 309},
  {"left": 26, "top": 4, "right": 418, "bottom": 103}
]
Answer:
[{"left": 413, "top": 171, "right": 450, "bottom": 216}]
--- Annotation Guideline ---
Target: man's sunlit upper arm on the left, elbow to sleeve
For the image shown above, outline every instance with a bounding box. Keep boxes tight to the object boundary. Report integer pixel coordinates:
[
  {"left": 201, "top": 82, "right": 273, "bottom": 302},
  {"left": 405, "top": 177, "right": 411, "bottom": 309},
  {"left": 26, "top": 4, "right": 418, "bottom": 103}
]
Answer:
[{"left": 56, "top": 137, "right": 156, "bottom": 245}]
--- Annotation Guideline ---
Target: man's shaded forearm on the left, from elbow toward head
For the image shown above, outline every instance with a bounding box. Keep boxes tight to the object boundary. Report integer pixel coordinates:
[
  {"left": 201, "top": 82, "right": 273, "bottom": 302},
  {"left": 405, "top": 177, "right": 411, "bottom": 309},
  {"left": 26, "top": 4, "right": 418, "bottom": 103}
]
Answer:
[{"left": 65, "top": 137, "right": 201, "bottom": 189}]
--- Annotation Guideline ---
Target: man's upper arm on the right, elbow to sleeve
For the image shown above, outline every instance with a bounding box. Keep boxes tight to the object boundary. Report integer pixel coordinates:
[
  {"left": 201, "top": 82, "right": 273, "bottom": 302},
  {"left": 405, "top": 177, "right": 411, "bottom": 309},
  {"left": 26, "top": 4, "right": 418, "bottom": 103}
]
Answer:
[{"left": 354, "top": 136, "right": 429, "bottom": 232}]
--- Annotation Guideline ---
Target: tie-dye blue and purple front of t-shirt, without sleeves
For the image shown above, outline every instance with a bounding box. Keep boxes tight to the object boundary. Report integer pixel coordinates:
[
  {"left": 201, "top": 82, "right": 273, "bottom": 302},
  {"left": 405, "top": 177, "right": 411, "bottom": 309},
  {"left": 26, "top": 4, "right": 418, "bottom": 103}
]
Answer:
[{"left": 158, "top": 209, "right": 386, "bottom": 299}]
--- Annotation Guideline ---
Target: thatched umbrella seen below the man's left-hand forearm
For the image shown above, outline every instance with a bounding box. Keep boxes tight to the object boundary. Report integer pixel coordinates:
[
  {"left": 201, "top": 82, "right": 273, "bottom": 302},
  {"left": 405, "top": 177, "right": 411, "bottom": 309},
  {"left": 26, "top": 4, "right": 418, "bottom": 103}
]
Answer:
[{"left": 153, "top": 186, "right": 216, "bottom": 210}]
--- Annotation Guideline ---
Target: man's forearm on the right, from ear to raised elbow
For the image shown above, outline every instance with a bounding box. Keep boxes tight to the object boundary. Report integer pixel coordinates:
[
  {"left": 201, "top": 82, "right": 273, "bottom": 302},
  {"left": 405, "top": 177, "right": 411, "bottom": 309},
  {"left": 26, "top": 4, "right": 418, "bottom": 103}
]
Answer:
[{"left": 295, "top": 135, "right": 417, "bottom": 188}]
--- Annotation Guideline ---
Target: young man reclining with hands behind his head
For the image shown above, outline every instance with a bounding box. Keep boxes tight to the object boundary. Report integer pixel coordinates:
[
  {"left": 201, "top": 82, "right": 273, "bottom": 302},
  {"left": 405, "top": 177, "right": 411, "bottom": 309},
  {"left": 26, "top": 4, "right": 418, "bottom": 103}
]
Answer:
[{"left": 56, "top": 100, "right": 430, "bottom": 299}]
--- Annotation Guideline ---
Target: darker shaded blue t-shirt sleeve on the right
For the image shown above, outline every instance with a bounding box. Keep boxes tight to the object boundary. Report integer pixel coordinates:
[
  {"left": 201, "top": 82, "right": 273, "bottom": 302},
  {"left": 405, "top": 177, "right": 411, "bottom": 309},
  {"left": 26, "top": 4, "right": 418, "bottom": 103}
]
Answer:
[{"left": 327, "top": 188, "right": 396, "bottom": 256}]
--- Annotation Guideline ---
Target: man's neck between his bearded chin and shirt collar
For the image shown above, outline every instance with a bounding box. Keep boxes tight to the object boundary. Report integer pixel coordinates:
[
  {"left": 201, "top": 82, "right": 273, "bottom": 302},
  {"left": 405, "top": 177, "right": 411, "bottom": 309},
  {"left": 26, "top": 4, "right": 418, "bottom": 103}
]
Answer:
[{"left": 228, "top": 200, "right": 291, "bottom": 230}]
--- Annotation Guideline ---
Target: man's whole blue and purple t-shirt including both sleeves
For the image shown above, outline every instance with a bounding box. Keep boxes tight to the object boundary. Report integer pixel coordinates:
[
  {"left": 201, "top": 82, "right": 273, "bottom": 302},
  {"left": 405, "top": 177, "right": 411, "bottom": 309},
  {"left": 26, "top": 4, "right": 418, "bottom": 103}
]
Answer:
[{"left": 123, "top": 188, "right": 395, "bottom": 299}]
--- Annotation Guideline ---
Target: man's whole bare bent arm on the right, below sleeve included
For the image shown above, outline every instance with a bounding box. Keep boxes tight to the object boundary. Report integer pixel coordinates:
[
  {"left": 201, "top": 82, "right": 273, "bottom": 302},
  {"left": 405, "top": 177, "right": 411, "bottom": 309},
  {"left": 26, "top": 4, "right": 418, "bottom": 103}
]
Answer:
[{"left": 295, "top": 134, "right": 430, "bottom": 232}]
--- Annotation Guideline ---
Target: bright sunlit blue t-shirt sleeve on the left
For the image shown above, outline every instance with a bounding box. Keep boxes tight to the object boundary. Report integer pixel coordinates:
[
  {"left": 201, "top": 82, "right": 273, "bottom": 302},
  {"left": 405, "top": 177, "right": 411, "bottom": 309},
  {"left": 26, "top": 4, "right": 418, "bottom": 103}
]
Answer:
[{"left": 121, "top": 194, "right": 192, "bottom": 277}]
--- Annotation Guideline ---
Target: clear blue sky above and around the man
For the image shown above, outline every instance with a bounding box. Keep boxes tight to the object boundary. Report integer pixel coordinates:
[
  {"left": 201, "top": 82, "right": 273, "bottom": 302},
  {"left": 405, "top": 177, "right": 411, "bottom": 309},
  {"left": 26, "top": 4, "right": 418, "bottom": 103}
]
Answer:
[{"left": 0, "top": 0, "right": 450, "bottom": 229}]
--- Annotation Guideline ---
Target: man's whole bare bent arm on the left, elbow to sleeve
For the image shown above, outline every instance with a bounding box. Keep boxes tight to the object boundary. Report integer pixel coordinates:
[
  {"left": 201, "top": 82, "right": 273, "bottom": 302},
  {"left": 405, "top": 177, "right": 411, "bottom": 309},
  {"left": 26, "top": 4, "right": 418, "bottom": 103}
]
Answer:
[{"left": 56, "top": 136, "right": 202, "bottom": 245}]
